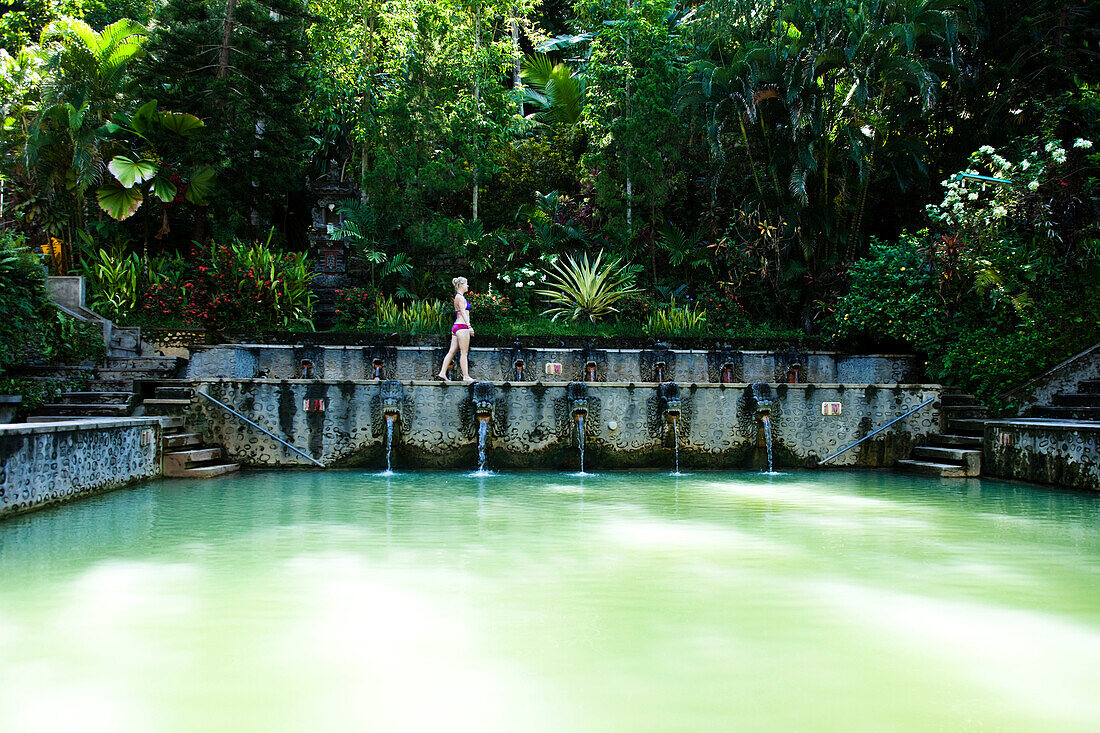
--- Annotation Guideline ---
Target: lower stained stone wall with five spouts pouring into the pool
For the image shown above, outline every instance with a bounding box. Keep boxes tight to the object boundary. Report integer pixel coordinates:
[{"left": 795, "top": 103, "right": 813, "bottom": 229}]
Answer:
[{"left": 189, "top": 380, "right": 941, "bottom": 468}]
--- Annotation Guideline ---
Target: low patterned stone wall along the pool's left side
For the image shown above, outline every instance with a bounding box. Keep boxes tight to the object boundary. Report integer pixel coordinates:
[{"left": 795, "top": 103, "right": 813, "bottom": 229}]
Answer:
[{"left": 0, "top": 418, "right": 161, "bottom": 517}]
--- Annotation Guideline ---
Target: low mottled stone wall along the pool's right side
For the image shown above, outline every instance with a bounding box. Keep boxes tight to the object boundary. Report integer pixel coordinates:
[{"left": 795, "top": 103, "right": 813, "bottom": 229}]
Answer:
[{"left": 981, "top": 420, "right": 1100, "bottom": 491}]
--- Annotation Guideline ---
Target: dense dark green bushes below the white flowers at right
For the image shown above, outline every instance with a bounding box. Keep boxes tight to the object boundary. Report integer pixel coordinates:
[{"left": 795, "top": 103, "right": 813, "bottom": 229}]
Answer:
[{"left": 835, "top": 234, "right": 1100, "bottom": 404}]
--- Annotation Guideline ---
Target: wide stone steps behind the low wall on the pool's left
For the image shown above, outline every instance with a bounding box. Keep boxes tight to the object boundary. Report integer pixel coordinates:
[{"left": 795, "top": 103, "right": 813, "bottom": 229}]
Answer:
[{"left": 28, "top": 355, "right": 184, "bottom": 422}]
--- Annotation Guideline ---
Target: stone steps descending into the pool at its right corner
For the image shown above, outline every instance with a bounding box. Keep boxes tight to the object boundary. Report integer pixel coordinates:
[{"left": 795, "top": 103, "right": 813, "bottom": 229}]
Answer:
[{"left": 895, "top": 392, "right": 989, "bottom": 479}]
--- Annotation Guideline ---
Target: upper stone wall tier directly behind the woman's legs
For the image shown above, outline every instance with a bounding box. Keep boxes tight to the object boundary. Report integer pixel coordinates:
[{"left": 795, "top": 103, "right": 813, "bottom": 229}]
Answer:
[{"left": 186, "top": 344, "right": 920, "bottom": 384}]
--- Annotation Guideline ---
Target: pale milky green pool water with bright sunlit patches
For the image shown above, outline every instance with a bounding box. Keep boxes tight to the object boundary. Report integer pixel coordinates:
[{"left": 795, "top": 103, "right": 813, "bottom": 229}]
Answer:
[{"left": 0, "top": 471, "right": 1100, "bottom": 733}]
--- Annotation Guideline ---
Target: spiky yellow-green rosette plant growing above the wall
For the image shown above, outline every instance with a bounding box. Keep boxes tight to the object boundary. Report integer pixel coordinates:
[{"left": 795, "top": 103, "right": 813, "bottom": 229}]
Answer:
[{"left": 538, "top": 250, "right": 639, "bottom": 324}]
